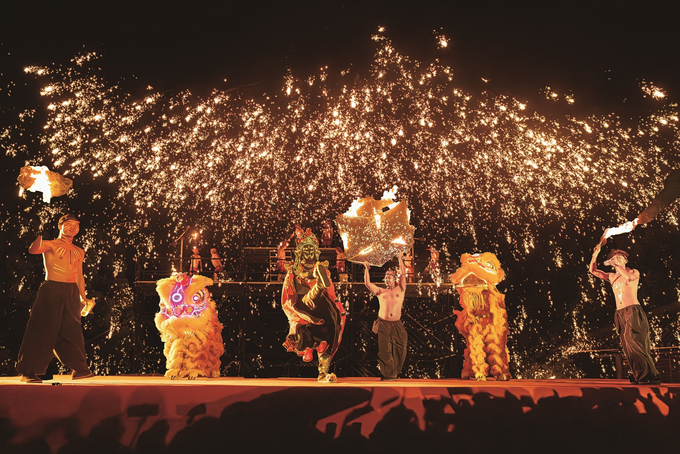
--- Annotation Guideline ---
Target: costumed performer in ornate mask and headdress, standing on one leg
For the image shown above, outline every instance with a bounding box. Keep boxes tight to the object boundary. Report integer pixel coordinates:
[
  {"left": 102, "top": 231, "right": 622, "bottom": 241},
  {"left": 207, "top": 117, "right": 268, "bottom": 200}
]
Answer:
[{"left": 281, "top": 229, "right": 345, "bottom": 382}]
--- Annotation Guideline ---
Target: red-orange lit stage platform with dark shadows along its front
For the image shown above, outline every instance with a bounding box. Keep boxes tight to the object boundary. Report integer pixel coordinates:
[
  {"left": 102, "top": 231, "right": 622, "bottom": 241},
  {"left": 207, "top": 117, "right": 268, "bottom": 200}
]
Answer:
[{"left": 0, "top": 376, "right": 680, "bottom": 454}]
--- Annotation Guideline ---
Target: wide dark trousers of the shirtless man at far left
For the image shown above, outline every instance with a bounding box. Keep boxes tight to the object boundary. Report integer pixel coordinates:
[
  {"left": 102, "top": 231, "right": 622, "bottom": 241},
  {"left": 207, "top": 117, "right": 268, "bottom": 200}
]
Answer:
[{"left": 17, "top": 281, "right": 90, "bottom": 377}]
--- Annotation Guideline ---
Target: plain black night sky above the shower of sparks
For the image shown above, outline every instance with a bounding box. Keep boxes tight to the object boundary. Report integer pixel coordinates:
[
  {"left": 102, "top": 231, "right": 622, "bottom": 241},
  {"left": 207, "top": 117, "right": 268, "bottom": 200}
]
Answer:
[{"left": 5, "top": 1, "right": 680, "bottom": 110}]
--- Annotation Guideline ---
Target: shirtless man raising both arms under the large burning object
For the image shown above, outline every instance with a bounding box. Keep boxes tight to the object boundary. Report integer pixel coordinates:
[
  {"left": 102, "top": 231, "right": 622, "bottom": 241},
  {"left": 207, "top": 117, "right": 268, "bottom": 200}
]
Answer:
[{"left": 364, "top": 253, "right": 408, "bottom": 380}]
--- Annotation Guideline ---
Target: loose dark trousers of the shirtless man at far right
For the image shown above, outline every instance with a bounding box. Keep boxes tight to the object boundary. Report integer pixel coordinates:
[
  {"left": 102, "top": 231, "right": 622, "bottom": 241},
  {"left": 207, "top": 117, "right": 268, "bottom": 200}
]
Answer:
[{"left": 614, "top": 304, "right": 659, "bottom": 381}]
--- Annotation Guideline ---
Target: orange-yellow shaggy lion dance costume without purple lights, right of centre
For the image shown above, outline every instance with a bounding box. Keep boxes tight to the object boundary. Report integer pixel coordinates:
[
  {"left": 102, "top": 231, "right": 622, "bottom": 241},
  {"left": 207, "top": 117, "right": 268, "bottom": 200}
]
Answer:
[{"left": 451, "top": 252, "right": 511, "bottom": 381}]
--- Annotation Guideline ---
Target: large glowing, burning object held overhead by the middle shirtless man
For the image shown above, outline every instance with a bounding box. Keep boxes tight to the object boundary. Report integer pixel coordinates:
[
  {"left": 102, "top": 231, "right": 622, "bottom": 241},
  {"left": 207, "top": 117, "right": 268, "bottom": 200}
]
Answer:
[{"left": 335, "top": 188, "right": 415, "bottom": 266}]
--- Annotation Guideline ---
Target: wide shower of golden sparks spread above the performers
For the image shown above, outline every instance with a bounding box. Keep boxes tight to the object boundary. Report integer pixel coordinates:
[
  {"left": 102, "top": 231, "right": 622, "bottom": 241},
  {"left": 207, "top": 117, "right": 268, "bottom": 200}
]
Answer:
[{"left": 0, "top": 34, "right": 680, "bottom": 377}]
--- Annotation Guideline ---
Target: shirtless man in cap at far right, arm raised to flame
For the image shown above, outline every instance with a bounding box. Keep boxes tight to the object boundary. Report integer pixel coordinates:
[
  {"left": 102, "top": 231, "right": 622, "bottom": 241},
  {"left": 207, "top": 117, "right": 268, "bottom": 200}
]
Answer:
[{"left": 589, "top": 245, "right": 661, "bottom": 385}]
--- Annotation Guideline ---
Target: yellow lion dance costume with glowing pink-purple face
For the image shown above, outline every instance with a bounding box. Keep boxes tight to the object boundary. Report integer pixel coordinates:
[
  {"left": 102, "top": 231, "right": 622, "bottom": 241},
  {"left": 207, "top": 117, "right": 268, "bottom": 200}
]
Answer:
[{"left": 155, "top": 274, "right": 224, "bottom": 380}]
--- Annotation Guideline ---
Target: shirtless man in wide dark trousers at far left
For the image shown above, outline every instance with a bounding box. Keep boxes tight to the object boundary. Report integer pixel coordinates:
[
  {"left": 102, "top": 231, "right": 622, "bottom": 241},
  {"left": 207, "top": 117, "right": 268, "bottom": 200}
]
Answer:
[{"left": 17, "top": 214, "right": 94, "bottom": 383}]
